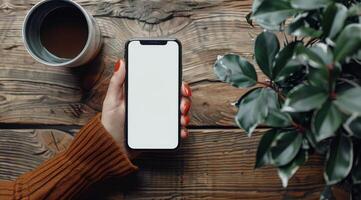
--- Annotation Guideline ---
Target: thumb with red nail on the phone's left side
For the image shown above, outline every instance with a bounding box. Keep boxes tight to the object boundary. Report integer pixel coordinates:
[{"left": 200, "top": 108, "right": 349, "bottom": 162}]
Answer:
[{"left": 106, "top": 60, "right": 126, "bottom": 102}]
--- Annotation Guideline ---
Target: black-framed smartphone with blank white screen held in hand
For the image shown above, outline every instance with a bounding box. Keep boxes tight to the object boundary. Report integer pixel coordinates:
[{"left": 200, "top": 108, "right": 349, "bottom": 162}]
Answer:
[{"left": 124, "top": 39, "right": 182, "bottom": 150}]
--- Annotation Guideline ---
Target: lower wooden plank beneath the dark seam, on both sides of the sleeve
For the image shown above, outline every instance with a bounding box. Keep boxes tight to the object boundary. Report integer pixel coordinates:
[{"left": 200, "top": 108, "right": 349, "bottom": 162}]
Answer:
[{"left": 0, "top": 129, "right": 338, "bottom": 199}]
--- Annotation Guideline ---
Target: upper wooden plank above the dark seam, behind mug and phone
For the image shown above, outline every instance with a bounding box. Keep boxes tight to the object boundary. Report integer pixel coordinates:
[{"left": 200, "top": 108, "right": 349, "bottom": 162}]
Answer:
[{"left": 0, "top": 0, "right": 265, "bottom": 126}]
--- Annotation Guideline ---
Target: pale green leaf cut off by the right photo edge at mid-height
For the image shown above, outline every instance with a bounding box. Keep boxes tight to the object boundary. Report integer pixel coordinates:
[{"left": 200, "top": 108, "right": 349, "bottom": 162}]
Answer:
[{"left": 335, "top": 87, "right": 361, "bottom": 114}]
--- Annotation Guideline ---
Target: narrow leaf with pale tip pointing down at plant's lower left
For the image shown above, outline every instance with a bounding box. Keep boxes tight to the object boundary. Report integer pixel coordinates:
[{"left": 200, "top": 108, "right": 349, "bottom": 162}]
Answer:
[{"left": 277, "top": 149, "right": 308, "bottom": 188}]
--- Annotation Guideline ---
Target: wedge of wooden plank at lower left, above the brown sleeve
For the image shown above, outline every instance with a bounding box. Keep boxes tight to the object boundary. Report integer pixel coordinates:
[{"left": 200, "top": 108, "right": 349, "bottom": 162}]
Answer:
[{"left": 0, "top": 129, "right": 73, "bottom": 180}]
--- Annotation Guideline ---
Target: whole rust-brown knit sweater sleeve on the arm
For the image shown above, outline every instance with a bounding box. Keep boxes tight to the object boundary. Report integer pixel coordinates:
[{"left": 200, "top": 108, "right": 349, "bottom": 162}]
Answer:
[{"left": 0, "top": 114, "right": 137, "bottom": 200}]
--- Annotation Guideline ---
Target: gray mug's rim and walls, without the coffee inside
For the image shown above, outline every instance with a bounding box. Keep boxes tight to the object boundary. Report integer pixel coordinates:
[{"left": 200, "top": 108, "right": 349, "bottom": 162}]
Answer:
[{"left": 22, "top": 0, "right": 102, "bottom": 67}]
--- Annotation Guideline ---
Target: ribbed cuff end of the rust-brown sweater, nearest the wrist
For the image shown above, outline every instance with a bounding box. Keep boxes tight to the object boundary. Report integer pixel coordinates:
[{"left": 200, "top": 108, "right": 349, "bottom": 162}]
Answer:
[{"left": 65, "top": 114, "right": 137, "bottom": 180}]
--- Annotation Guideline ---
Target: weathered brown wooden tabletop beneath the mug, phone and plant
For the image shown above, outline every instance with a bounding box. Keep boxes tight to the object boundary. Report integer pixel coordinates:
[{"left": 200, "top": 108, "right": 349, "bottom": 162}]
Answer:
[{"left": 0, "top": 0, "right": 340, "bottom": 200}]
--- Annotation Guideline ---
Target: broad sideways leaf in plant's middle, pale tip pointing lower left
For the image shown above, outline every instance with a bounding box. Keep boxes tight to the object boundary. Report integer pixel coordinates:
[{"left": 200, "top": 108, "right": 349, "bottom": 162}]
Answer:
[{"left": 282, "top": 84, "right": 328, "bottom": 112}]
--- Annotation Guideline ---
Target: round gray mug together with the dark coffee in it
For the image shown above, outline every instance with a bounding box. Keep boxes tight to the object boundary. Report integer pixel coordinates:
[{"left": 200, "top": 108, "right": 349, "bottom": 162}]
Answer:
[{"left": 22, "top": 0, "right": 102, "bottom": 67}]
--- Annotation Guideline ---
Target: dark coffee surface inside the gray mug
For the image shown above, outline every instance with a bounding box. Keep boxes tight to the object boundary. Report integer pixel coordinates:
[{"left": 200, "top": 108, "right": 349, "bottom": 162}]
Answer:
[{"left": 40, "top": 7, "right": 88, "bottom": 59}]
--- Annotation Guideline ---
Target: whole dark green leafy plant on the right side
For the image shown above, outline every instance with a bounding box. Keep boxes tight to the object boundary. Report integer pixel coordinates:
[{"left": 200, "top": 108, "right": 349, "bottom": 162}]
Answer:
[{"left": 214, "top": 0, "right": 361, "bottom": 198}]
